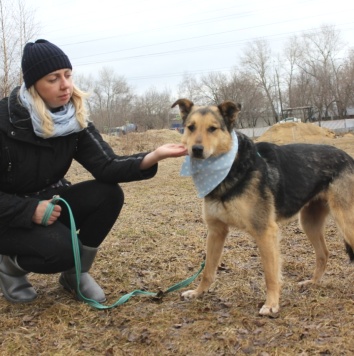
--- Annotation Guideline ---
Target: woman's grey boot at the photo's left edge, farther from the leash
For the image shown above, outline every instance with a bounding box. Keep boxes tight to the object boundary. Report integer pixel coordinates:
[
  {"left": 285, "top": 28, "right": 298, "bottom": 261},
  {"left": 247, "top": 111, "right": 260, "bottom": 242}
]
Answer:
[{"left": 0, "top": 255, "right": 37, "bottom": 303}]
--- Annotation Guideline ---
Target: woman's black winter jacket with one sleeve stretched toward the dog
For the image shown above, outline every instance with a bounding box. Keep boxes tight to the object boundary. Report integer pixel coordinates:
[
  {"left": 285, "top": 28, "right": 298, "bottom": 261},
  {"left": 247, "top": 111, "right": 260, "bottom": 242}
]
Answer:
[{"left": 0, "top": 88, "right": 157, "bottom": 228}]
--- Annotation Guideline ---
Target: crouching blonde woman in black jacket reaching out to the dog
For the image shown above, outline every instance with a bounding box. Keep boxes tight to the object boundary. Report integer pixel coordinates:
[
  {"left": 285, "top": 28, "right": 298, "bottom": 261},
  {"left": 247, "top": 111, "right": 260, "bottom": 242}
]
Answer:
[{"left": 0, "top": 40, "right": 186, "bottom": 303}]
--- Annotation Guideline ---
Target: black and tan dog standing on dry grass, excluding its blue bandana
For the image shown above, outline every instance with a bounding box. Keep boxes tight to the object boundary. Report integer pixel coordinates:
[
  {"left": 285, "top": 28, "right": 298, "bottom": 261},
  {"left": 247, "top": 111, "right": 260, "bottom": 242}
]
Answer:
[{"left": 172, "top": 99, "right": 354, "bottom": 316}]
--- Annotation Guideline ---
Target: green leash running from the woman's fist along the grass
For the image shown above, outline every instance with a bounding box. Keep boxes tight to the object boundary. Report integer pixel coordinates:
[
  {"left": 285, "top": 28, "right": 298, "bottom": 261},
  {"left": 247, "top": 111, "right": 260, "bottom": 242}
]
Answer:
[{"left": 41, "top": 196, "right": 205, "bottom": 310}]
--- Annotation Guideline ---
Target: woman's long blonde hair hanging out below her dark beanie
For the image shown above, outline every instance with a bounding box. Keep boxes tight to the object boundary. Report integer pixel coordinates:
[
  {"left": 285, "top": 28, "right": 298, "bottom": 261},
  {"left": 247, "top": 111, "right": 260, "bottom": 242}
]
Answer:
[{"left": 28, "top": 85, "right": 89, "bottom": 137}]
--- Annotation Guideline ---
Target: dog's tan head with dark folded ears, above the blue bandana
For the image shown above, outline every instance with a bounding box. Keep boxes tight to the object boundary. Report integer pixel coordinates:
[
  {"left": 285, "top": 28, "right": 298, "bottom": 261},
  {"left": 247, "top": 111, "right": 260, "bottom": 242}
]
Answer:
[{"left": 172, "top": 99, "right": 241, "bottom": 159}]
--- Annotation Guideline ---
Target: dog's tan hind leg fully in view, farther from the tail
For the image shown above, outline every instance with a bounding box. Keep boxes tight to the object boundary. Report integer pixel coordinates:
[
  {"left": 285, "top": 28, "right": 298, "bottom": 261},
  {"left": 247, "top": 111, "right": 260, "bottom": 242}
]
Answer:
[{"left": 299, "top": 199, "right": 329, "bottom": 285}]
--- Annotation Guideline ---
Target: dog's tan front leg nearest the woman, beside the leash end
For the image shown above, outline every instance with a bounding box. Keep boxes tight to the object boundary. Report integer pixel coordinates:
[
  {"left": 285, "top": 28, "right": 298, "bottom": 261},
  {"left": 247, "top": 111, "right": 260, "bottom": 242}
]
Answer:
[{"left": 182, "top": 221, "right": 229, "bottom": 299}]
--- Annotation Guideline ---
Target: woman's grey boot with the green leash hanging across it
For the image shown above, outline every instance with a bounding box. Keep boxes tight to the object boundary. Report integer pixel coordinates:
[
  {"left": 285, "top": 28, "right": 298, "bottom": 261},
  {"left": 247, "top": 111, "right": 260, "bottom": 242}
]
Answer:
[{"left": 59, "top": 246, "right": 106, "bottom": 303}]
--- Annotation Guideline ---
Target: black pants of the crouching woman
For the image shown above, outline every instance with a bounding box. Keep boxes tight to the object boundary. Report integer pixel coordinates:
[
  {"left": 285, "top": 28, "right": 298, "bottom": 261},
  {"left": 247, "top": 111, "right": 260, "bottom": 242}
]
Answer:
[{"left": 0, "top": 181, "right": 124, "bottom": 274}]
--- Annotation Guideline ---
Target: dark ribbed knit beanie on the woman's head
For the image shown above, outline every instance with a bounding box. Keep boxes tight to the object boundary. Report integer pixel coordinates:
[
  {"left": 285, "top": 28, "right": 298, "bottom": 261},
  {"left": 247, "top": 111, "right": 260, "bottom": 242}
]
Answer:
[{"left": 22, "top": 40, "right": 72, "bottom": 89}]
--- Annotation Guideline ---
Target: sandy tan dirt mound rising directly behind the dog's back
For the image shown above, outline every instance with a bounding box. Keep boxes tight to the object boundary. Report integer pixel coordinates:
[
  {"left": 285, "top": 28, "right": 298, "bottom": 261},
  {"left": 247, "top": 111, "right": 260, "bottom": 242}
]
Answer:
[{"left": 256, "top": 122, "right": 336, "bottom": 144}]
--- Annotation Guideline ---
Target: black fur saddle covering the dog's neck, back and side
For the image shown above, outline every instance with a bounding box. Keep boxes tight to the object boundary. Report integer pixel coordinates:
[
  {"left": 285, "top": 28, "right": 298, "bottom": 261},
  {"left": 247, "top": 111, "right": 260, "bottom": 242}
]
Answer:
[{"left": 208, "top": 132, "right": 354, "bottom": 220}]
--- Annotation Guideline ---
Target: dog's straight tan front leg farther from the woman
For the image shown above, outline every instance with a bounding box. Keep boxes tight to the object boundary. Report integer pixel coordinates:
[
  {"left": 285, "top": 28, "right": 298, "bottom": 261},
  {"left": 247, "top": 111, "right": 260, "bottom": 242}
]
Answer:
[{"left": 256, "top": 222, "right": 281, "bottom": 315}]
